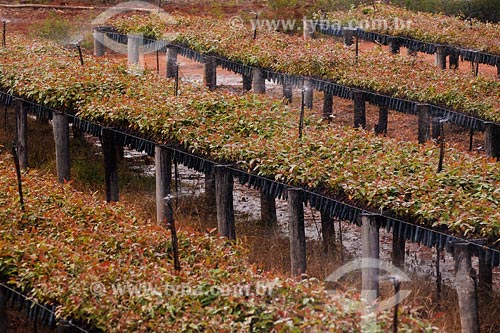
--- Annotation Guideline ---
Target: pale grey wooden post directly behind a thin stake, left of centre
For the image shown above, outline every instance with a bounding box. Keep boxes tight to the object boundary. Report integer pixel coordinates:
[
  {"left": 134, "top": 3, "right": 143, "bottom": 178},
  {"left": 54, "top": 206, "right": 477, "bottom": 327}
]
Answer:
[{"left": 155, "top": 145, "right": 172, "bottom": 226}]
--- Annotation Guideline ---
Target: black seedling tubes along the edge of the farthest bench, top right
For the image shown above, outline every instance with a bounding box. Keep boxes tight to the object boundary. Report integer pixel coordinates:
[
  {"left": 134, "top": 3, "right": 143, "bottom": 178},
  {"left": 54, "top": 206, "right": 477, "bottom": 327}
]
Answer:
[{"left": 316, "top": 24, "right": 500, "bottom": 66}]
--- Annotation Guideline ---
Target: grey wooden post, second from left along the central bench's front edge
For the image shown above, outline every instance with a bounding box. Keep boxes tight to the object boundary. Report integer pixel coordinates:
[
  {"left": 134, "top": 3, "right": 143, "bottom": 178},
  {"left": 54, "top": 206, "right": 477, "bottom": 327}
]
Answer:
[{"left": 52, "top": 112, "right": 71, "bottom": 184}]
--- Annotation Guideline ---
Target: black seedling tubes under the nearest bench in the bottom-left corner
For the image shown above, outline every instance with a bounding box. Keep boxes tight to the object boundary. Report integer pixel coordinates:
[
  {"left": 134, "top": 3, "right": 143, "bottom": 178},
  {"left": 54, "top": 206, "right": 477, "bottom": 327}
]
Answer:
[{"left": 0, "top": 283, "right": 93, "bottom": 333}]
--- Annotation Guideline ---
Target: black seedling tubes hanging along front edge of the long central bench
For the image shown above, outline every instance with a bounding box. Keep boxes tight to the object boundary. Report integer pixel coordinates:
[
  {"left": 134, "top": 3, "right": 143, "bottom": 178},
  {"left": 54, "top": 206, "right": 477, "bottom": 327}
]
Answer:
[{"left": 3, "top": 92, "right": 500, "bottom": 266}]
